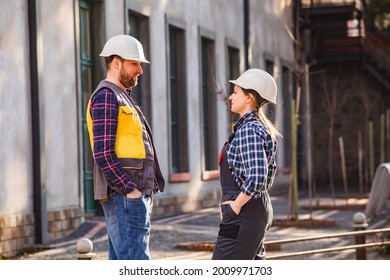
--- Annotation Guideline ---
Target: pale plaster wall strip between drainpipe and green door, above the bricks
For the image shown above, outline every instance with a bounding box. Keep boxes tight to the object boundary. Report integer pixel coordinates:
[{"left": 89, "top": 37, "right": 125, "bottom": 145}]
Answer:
[{"left": 40, "top": 0, "right": 80, "bottom": 210}]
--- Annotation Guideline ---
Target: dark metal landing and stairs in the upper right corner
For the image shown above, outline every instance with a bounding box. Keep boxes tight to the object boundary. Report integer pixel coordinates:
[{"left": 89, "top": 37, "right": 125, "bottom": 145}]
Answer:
[{"left": 301, "top": 1, "right": 390, "bottom": 90}]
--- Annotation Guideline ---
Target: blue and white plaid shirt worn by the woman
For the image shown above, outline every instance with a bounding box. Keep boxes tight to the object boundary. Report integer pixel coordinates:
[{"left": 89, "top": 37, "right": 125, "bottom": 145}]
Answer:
[{"left": 226, "top": 111, "right": 277, "bottom": 198}]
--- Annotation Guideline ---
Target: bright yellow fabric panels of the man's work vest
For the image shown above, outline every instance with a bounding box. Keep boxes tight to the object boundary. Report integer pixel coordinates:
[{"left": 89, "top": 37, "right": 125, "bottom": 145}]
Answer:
[{"left": 86, "top": 101, "right": 146, "bottom": 162}]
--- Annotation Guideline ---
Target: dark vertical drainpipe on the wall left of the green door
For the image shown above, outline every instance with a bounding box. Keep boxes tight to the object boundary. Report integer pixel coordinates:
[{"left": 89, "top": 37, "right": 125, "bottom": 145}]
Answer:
[{"left": 27, "top": 0, "right": 47, "bottom": 244}]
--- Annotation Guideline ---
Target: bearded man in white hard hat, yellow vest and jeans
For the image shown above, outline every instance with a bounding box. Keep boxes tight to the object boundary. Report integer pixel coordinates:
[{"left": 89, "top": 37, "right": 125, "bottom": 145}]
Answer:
[{"left": 87, "top": 35, "right": 165, "bottom": 260}]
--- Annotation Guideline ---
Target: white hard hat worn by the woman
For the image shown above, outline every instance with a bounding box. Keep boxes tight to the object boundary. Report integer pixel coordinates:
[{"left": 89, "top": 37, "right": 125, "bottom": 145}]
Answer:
[{"left": 229, "top": 68, "right": 277, "bottom": 104}]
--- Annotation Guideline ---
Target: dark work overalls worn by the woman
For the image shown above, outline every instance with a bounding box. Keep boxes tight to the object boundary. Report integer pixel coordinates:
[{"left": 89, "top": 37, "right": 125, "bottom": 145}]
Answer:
[{"left": 212, "top": 141, "right": 273, "bottom": 260}]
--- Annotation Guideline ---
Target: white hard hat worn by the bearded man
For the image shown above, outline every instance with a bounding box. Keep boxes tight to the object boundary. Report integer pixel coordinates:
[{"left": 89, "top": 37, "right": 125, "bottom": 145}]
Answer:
[{"left": 100, "top": 35, "right": 149, "bottom": 63}]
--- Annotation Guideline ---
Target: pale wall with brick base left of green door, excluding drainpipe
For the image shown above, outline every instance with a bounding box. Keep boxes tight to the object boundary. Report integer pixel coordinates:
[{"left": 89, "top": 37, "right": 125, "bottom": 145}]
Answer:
[{"left": 0, "top": 0, "right": 82, "bottom": 256}]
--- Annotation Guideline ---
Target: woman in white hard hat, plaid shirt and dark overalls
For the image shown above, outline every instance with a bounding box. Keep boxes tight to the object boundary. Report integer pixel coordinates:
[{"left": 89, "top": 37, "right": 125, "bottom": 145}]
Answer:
[{"left": 212, "top": 69, "right": 280, "bottom": 260}]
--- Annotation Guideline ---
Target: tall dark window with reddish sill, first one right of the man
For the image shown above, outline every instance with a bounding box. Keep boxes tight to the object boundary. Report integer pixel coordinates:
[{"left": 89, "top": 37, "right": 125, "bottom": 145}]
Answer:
[{"left": 168, "top": 26, "right": 191, "bottom": 182}]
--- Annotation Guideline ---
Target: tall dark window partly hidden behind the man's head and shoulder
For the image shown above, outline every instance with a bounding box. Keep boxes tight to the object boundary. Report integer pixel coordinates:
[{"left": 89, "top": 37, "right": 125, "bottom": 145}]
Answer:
[{"left": 128, "top": 11, "right": 152, "bottom": 121}]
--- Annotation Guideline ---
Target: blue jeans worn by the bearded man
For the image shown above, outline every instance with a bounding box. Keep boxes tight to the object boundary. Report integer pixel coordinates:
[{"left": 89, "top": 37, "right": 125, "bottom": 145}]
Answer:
[{"left": 101, "top": 193, "right": 153, "bottom": 260}]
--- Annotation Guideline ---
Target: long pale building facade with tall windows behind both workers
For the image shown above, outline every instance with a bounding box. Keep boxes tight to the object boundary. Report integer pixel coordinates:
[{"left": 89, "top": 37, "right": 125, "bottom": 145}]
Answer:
[{"left": 0, "top": 0, "right": 294, "bottom": 257}]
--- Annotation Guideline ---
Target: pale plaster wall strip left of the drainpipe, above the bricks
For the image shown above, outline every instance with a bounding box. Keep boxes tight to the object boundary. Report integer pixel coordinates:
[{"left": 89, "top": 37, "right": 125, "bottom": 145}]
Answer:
[{"left": 0, "top": 0, "right": 32, "bottom": 216}]
